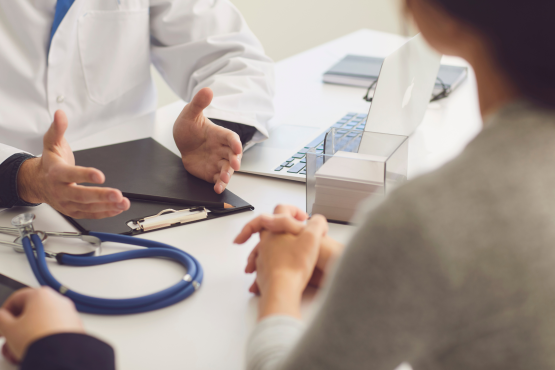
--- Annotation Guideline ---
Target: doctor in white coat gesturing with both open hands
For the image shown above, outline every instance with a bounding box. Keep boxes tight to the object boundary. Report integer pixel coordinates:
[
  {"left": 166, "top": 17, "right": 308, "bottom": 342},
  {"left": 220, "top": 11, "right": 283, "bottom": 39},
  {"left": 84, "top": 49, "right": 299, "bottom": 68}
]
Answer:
[{"left": 0, "top": 0, "right": 274, "bottom": 218}]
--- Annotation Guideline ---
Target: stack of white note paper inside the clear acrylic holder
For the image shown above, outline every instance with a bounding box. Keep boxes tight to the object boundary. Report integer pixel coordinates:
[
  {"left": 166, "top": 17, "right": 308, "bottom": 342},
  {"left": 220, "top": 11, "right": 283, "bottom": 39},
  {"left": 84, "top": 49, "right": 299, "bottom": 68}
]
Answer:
[{"left": 312, "top": 152, "right": 387, "bottom": 222}]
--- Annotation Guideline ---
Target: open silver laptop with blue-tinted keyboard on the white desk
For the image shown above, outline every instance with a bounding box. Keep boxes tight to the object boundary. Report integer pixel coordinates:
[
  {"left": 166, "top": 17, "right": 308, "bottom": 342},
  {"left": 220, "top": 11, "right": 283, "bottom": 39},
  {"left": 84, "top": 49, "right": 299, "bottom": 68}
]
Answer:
[{"left": 240, "top": 34, "right": 441, "bottom": 182}]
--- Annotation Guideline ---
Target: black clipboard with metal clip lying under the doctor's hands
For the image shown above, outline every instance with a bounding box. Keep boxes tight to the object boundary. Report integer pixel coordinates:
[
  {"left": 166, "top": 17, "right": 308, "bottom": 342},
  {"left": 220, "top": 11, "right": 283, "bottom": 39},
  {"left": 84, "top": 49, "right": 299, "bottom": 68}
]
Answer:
[{"left": 65, "top": 138, "right": 254, "bottom": 235}]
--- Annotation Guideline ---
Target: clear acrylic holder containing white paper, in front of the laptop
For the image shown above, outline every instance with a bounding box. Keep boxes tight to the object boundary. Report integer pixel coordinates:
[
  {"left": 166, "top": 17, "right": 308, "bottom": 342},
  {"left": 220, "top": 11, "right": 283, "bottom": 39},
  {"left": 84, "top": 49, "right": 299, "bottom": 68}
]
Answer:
[{"left": 306, "top": 130, "right": 408, "bottom": 223}]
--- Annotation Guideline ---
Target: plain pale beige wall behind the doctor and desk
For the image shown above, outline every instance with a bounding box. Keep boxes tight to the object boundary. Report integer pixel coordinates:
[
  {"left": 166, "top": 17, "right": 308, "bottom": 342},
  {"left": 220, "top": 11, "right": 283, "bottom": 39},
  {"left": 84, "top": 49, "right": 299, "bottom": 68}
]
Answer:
[{"left": 153, "top": 0, "right": 404, "bottom": 107}]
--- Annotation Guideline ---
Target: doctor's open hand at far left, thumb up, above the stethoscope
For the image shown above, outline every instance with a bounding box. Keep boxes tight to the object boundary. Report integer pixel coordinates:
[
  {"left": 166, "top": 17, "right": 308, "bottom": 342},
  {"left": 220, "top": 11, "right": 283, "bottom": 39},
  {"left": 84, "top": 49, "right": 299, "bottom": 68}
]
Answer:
[{"left": 17, "top": 110, "right": 130, "bottom": 219}]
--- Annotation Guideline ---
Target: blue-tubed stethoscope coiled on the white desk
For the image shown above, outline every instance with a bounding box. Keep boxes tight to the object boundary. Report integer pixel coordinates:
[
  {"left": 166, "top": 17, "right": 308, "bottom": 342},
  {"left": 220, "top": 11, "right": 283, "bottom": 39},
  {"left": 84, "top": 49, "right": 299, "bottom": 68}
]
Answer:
[{"left": 0, "top": 213, "right": 203, "bottom": 315}]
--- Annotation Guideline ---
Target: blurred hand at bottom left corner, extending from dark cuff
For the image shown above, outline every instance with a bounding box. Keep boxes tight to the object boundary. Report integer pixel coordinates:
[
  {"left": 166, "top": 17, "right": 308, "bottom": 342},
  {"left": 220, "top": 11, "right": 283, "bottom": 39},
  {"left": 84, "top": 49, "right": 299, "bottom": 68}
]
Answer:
[{"left": 0, "top": 287, "right": 85, "bottom": 363}]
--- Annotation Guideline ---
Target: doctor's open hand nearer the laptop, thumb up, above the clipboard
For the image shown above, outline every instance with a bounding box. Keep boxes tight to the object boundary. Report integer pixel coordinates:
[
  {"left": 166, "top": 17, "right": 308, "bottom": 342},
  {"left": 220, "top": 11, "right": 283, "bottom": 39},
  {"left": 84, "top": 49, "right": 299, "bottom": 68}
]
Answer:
[{"left": 173, "top": 88, "right": 243, "bottom": 194}]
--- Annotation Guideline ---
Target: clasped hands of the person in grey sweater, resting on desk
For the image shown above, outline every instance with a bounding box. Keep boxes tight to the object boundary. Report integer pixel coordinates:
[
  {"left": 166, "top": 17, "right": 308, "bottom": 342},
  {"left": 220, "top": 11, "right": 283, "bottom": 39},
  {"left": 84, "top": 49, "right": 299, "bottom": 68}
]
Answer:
[{"left": 235, "top": 206, "right": 344, "bottom": 318}]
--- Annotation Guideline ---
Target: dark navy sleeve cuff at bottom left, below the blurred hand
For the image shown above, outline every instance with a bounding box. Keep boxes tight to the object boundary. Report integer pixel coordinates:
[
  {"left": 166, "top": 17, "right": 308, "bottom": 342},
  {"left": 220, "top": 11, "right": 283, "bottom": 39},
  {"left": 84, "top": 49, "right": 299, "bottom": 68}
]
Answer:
[{"left": 20, "top": 333, "right": 116, "bottom": 370}]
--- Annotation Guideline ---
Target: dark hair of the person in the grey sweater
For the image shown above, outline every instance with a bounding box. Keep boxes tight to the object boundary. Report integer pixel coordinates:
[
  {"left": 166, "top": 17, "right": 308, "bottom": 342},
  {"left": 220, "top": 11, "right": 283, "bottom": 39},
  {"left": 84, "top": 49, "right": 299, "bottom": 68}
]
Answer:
[{"left": 431, "top": 0, "right": 555, "bottom": 108}]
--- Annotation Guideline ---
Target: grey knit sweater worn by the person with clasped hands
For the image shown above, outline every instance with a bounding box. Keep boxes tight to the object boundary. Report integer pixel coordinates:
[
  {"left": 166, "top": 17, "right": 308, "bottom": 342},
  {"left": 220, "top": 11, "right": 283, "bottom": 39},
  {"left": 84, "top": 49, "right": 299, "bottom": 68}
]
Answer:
[{"left": 247, "top": 102, "right": 555, "bottom": 370}]
